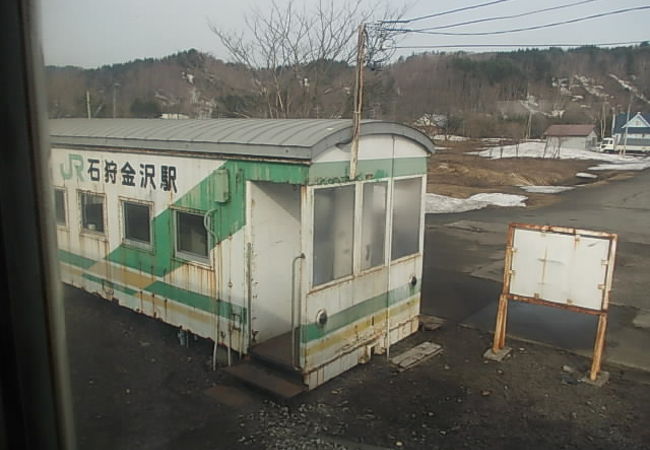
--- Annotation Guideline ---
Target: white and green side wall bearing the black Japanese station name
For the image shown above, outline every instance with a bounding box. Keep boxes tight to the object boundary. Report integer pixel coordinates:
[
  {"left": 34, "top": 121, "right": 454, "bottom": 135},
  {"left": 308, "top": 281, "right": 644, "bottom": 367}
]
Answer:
[{"left": 51, "top": 148, "right": 247, "bottom": 349}]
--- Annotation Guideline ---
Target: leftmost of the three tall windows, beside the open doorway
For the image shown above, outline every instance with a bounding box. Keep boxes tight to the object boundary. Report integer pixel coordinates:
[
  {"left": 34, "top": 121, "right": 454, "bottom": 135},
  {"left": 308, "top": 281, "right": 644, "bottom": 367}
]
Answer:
[{"left": 313, "top": 185, "right": 354, "bottom": 286}]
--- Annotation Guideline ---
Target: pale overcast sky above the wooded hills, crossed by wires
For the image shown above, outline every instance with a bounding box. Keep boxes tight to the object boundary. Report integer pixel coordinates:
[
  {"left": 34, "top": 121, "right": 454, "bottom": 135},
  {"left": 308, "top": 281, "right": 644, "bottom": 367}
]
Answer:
[{"left": 41, "top": 0, "right": 650, "bottom": 67}]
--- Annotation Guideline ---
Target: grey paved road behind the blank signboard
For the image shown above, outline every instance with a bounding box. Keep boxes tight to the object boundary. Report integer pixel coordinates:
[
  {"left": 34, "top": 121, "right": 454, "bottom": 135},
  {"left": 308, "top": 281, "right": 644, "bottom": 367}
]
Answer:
[{"left": 422, "top": 171, "right": 650, "bottom": 370}]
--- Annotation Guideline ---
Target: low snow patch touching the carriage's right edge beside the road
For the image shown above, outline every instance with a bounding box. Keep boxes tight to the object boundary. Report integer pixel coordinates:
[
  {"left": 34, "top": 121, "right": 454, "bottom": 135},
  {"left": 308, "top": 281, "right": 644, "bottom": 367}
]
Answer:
[{"left": 425, "top": 193, "right": 528, "bottom": 214}]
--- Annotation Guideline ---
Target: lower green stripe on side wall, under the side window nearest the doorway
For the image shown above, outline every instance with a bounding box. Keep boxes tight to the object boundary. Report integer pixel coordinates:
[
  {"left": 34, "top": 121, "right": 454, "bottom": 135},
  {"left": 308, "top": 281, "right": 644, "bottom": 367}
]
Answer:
[{"left": 144, "top": 281, "right": 246, "bottom": 322}]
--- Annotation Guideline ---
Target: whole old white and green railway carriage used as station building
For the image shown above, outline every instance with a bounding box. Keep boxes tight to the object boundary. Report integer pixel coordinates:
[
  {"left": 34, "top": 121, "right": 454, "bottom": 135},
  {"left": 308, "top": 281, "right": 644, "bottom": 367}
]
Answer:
[{"left": 51, "top": 119, "right": 433, "bottom": 394}]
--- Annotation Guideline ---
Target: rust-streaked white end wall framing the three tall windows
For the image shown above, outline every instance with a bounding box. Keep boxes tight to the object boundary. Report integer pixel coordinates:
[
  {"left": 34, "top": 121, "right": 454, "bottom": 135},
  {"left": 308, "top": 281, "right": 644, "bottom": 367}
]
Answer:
[{"left": 300, "top": 135, "right": 427, "bottom": 387}]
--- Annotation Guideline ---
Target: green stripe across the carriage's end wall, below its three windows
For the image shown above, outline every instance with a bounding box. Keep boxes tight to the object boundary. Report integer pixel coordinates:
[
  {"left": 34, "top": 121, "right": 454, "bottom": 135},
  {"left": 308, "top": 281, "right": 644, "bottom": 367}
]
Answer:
[{"left": 301, "top": 282, "right": 420, "bottom": 343}]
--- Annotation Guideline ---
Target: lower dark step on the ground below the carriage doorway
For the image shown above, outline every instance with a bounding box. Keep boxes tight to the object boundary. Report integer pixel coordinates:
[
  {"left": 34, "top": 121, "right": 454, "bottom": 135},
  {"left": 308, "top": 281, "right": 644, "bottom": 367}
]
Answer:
[{"left": 224, "top": 360, "right": 307, "bottom": 399}]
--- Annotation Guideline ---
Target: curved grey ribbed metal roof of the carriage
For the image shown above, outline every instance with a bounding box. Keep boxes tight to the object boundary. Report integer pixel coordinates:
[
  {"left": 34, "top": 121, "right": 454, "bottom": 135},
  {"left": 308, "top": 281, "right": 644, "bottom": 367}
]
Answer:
[{"left": 50, "top": 119, "right": 433, "bottom": 160}]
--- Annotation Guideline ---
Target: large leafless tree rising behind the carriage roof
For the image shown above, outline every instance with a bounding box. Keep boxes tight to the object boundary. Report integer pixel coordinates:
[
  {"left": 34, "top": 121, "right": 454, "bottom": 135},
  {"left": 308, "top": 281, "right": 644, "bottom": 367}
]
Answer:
[{"left": 210, "top": 0, "right": 403, "bottom": 118}]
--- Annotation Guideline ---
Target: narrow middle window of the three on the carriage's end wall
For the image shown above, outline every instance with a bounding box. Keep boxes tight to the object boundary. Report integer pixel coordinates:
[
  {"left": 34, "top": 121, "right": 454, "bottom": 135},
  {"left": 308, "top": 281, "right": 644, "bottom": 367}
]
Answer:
[{"left": 361, "top": 181, "right": 388, "bottom": 270}]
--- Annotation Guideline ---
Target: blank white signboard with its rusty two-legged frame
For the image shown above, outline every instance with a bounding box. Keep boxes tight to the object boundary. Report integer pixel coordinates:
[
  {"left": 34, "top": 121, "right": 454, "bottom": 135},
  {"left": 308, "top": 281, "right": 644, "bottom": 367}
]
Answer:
[{"left": 485, "top": 223, "right": 618, "bottom": 382}]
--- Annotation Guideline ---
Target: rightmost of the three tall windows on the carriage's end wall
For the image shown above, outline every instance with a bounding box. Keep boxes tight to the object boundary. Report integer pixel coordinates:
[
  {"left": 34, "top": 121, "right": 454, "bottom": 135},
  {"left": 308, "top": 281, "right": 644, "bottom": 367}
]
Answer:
[{"left": 391, "top": 178, "right": 422, "bottom": 260}]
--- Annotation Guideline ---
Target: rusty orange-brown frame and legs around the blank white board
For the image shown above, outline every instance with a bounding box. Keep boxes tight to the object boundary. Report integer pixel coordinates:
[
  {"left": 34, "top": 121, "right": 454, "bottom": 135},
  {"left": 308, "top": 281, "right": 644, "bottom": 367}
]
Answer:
[{"left": 492, "top": 222, "right": 618, "bottom": 381}]
